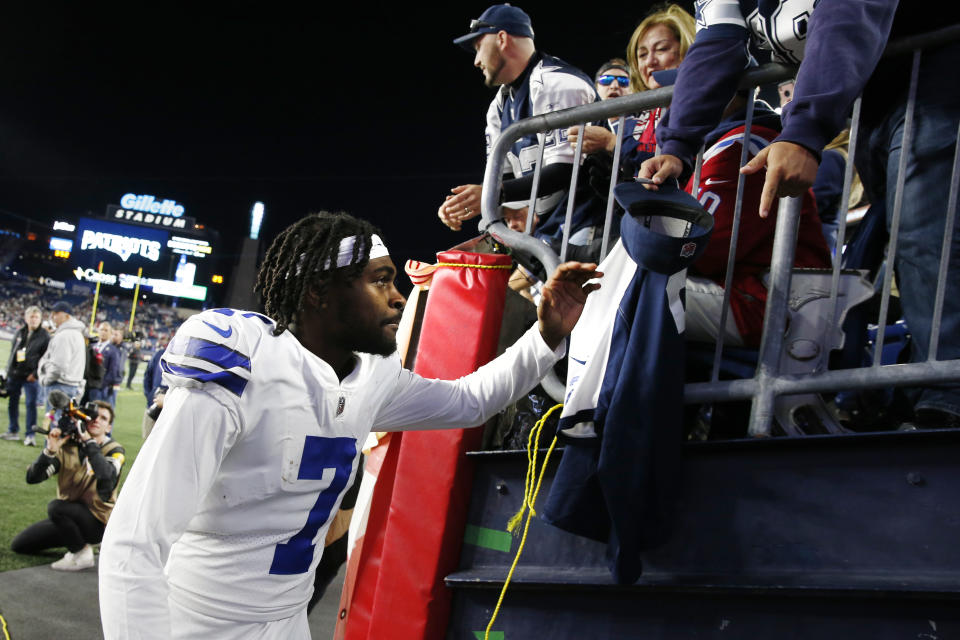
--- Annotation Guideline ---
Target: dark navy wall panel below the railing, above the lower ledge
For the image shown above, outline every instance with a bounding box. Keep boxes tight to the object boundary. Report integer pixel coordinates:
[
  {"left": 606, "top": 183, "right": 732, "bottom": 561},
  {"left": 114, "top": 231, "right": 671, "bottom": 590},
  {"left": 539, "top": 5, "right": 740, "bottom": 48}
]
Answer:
[{"left": 459, "top": 432, "right": 960, "bottom": 593}]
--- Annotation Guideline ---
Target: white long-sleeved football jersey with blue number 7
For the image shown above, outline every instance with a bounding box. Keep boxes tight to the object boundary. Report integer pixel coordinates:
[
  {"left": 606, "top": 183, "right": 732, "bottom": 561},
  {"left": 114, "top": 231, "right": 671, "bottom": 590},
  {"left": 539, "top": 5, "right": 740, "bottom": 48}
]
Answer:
[{"left": 100, "top": 309, "right": 558, "bottom": 638}]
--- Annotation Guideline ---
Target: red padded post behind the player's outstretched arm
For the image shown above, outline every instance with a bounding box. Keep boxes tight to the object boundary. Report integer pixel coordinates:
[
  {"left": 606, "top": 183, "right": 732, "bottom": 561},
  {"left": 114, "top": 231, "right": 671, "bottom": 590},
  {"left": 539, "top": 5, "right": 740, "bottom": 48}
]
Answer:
[{"left": 346, "top": 251, "right": 511, "bottom": 640}]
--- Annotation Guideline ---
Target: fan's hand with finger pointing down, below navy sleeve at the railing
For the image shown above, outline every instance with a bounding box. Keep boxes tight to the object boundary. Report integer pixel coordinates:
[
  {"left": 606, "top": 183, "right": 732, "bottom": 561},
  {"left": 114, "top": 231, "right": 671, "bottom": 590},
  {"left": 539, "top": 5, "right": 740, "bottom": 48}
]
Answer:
[{"left": 740, "top": 141, "right": 818, "bottom": 218}]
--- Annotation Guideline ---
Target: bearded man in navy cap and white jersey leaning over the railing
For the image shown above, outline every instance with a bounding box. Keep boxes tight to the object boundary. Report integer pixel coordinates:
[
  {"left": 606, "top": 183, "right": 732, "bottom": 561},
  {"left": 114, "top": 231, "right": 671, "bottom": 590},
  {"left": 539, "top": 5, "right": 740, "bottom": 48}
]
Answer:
[{"left": 437, "top": 4, "right": 603, "bottom": 254}]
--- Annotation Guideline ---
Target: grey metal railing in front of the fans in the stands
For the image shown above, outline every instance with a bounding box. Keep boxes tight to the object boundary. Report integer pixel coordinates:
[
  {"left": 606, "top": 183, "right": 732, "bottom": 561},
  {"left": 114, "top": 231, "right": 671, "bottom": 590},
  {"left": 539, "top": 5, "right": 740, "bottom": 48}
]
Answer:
[{"left": 481, "top": 25, "right": 960, "bottom": 436}]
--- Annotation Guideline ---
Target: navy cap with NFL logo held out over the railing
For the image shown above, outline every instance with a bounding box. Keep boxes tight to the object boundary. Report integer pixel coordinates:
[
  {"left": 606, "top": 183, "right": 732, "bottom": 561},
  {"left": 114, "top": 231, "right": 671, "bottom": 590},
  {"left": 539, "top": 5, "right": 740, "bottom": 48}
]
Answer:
[{"left": 613, "top": 180, "right": 713, "bottom": 274}]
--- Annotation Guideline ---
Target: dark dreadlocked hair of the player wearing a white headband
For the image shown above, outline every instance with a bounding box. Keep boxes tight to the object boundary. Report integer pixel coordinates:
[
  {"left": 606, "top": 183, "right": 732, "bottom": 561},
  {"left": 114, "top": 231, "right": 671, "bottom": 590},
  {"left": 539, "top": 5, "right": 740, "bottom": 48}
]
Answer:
[{"left": 254, "top": 211, "right": 378, "bottom": 335}]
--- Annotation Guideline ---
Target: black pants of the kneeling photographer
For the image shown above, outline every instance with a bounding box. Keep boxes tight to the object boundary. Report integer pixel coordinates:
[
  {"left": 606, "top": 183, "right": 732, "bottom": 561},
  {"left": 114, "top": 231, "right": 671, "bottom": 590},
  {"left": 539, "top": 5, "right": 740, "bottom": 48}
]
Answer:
[{"left": 10, "top": 500, "right": 106, "bottom": 553}]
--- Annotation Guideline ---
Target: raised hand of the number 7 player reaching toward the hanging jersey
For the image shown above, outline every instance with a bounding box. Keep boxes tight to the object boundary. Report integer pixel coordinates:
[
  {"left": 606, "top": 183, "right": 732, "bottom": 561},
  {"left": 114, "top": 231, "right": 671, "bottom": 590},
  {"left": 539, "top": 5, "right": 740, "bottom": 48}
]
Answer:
[{"left": 537, "top": 262, "right": 603, "bottom": 349}]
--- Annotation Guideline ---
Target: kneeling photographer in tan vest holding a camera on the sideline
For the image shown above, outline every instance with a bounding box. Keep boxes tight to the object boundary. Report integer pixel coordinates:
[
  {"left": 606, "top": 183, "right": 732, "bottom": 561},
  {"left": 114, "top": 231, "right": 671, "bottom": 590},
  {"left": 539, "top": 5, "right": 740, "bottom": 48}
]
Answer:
[{"left": 10, "top": 400, "right": 124, "bottom": 571}]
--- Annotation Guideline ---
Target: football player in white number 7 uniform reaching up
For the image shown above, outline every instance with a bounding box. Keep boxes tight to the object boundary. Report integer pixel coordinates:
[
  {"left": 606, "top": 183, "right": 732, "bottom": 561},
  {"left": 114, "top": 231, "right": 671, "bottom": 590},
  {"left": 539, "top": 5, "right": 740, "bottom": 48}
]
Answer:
[{"left": 100, "top": 213, "right": 600, "bottom": 640}]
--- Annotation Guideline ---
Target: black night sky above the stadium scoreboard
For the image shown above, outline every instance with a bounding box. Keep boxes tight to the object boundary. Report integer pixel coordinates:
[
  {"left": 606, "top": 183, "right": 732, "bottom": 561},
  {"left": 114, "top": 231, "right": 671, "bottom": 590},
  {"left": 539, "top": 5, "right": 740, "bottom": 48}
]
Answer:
[{"left": 0, "top": 2, "right": 676, "bottom": 284}]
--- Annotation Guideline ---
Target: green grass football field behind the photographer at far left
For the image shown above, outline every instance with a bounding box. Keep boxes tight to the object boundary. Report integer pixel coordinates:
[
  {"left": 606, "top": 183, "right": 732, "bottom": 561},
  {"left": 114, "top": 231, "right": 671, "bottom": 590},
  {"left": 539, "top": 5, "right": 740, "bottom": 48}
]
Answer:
[{"left": 0, "top": 340, "right": 146, "bottom": 571}]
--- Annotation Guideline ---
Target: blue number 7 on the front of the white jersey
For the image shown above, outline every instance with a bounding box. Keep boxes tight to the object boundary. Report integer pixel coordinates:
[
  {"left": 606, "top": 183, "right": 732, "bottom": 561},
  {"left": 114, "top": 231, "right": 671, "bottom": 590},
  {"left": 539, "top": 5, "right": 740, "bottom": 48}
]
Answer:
[{"left": 270, "top": 436, "right": 357, "bottom": 575}]
